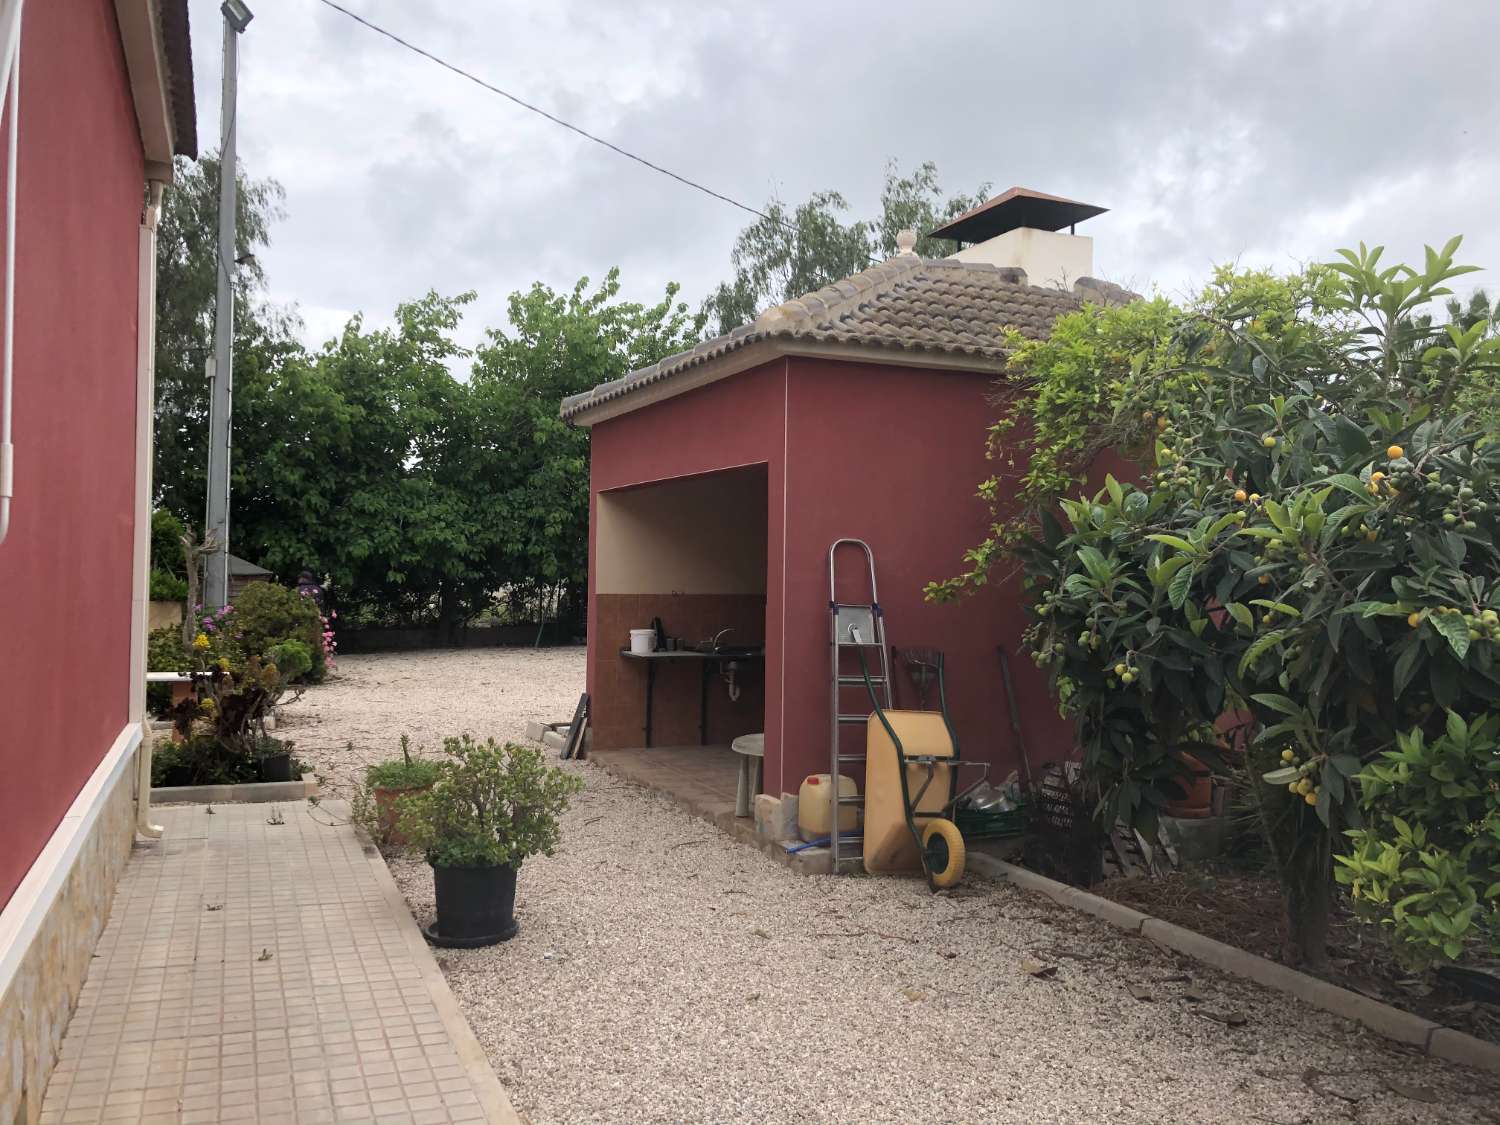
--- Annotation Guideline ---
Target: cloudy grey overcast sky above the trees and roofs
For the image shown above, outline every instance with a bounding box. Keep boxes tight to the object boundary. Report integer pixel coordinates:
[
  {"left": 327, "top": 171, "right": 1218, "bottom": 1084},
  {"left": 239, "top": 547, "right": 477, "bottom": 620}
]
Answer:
[{"left": 192, "top": 0, "right": 1500, "bottom": 352}]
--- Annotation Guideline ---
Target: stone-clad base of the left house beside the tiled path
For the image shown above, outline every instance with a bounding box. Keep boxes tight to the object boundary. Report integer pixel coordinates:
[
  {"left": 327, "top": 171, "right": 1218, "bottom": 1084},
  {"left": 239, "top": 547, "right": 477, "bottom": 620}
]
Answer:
[{"left": 0, "top": 750, "right": 143, "bottom": 1125}]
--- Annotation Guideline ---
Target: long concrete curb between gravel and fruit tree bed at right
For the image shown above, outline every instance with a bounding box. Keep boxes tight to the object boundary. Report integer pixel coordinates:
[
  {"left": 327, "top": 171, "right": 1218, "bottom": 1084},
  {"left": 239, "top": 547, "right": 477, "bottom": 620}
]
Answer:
[{"left": 969, "top": 852, "right": 1500, "bottom": 1074}]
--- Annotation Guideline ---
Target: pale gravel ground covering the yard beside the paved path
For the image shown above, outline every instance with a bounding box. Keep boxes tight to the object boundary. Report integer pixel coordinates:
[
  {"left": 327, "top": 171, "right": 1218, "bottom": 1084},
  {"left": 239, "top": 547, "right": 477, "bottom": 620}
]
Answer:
[{"left": 287, "top": 650, "right": 1500, "bottom": 1125}]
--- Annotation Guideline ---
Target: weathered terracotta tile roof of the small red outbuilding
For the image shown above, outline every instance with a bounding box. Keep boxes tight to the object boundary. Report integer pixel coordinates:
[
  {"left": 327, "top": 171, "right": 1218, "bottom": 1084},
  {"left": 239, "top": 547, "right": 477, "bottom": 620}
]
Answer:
[{"left": 563, "top": 255, "right": 1133, "bottom": 419}]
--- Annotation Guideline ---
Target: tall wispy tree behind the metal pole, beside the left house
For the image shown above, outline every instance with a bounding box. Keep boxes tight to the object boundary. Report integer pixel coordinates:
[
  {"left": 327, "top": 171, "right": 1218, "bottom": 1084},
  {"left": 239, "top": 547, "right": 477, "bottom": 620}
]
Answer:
[{"left": 153, "top": 155, "right": 296, "bottom": 521}]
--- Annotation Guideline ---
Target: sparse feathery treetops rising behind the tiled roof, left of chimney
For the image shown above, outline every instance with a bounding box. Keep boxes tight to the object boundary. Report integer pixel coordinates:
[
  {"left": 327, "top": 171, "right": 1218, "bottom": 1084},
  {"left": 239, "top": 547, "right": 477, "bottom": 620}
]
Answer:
[{"left": 704, "top": 161, "right": 989, "bottom": 335}]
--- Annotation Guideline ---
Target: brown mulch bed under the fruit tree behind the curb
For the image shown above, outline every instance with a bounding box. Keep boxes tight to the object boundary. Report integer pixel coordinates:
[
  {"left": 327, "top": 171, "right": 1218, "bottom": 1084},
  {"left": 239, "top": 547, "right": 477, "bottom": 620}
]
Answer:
[{"left": 1091, "top": 872, "right": 1500, "bottom": 1043}]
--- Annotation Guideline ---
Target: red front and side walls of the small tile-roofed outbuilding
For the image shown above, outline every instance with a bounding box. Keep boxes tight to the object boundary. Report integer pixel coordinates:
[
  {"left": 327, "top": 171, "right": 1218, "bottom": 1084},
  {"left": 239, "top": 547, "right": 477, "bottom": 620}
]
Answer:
[{"left": 588, "top": 356, "right": 1071, "bottom": 794}]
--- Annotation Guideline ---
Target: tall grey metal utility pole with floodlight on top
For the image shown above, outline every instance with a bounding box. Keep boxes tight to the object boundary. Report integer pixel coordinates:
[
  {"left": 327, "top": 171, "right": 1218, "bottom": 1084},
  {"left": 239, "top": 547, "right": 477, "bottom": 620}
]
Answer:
[{"left": 203, "top": 0, "right": 254, "bottom": 609}]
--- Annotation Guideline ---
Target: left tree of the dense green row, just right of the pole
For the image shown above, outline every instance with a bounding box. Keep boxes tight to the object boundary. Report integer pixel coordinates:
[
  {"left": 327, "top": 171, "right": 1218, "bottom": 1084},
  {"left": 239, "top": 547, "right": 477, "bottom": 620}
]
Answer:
[{"left": 231, "top": 294, "right": 483, "bottom": 620}]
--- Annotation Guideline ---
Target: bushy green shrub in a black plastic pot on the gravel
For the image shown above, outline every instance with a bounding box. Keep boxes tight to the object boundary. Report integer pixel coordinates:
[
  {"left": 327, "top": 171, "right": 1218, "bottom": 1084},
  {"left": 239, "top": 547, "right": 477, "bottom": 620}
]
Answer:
[{"left": 399, "top": 735, "right": 584, "bottom": 948}]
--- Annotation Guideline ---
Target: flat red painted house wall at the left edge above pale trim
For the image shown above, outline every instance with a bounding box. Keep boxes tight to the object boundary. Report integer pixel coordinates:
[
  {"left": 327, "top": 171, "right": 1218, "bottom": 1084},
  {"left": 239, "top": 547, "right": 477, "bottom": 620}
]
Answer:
[{"left": 0, "top": 0, "right": 144, "bottom": 906}]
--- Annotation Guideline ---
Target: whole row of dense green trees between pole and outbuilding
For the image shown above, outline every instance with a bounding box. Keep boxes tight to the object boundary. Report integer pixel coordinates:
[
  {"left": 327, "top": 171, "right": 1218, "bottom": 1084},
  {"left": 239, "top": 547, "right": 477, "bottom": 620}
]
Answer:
[{"left": 233, "top": 272, "right": 698, "bottom": 633}]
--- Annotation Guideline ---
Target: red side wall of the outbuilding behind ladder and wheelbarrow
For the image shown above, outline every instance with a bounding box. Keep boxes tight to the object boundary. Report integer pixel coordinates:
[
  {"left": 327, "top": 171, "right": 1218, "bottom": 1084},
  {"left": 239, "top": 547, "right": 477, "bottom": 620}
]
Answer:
[{"left": 768, "top": 359, "right": 1071, "bottom": 792}]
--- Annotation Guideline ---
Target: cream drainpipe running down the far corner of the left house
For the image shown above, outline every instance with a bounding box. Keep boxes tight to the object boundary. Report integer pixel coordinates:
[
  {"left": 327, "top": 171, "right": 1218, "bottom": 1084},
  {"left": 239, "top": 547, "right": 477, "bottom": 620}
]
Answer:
[{"left": 131, "top": 180, "right": 165, "bottom": 840}]
